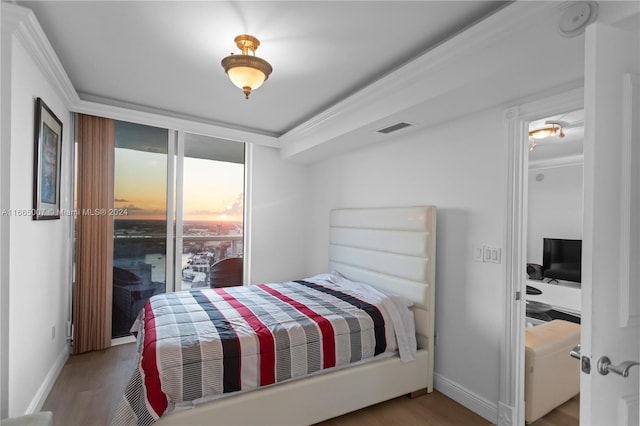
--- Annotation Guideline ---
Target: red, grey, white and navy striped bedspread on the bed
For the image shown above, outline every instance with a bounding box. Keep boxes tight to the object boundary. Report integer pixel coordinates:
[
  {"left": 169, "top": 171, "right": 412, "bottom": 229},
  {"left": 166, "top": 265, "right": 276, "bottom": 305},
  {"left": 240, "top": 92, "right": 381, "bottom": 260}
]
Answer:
[{"left": 112, "top": 274, "right": 410, "bottom": 425}]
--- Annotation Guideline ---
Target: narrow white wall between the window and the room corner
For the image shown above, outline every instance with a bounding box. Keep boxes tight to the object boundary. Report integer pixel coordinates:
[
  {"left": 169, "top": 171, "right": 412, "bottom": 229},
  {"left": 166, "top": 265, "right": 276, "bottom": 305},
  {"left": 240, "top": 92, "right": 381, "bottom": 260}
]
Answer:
[{"left": 247, "top": 145, "right": 310, "bottom": 284}]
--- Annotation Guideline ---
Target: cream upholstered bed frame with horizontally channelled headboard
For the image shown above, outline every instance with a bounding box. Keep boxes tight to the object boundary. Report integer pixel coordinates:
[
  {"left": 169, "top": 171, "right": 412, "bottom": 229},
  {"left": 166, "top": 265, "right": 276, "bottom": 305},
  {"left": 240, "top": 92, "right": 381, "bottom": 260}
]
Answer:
[{"left": 155, "top": 206, "right": 436, "bottom": 426}]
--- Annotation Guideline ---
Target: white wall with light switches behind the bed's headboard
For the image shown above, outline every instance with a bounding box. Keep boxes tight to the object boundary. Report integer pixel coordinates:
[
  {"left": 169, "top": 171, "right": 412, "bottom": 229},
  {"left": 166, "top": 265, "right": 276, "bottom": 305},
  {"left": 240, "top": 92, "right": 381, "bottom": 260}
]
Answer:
[{"left": 310, "top": 110, "right": 507, "bottom": 421}]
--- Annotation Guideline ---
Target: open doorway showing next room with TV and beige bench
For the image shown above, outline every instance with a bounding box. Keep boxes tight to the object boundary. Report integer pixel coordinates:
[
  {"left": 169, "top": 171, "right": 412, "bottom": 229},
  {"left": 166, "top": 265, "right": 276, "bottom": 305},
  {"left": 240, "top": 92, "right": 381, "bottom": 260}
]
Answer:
[{"left": 523, "top": 109, "right": 584, "bottom": 426}]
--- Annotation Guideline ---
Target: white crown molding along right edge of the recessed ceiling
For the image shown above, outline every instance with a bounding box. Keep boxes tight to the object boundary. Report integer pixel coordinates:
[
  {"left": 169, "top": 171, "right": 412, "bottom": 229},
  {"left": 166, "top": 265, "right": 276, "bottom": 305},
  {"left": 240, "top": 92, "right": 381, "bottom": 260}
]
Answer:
[{"left": 279, "top": 2, "right": 564, "bottom": 158}]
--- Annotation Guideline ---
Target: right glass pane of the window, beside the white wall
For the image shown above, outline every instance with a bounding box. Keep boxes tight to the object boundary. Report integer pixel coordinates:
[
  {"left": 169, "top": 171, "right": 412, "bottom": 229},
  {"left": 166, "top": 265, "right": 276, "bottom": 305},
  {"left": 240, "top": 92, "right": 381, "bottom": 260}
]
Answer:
[{"left": 177, "top": 133, "right": 245, "bottom": 289}]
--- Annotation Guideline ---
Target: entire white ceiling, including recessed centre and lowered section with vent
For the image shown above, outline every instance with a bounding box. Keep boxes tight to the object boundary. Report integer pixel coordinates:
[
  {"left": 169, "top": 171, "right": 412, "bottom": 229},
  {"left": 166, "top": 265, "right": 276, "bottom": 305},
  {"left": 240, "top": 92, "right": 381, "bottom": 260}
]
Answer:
[{"left": 13, "top": 0, "right": 640, "bottom": 163}]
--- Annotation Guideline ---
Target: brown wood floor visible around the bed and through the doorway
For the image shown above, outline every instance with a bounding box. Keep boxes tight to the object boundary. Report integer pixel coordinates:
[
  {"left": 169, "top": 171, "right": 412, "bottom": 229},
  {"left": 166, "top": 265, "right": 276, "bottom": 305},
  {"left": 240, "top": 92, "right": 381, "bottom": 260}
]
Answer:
[{"left": 42, "top": 343, "right": 579, "bottom": 426}]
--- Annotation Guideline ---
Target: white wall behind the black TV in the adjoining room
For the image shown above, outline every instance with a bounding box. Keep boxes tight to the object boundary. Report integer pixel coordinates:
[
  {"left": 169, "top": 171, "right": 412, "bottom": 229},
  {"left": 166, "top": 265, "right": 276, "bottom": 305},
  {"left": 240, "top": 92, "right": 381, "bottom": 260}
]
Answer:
[{"left": 527, "top": 164, "right": 582, "bottom": 265}]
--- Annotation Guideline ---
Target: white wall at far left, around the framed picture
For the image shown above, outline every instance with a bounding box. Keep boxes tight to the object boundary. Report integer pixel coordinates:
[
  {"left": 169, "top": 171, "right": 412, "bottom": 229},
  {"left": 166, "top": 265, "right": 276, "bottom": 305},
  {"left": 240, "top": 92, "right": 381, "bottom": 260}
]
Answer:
[{"left": 1, "top": 22, "right": 72, "bottom": 416}]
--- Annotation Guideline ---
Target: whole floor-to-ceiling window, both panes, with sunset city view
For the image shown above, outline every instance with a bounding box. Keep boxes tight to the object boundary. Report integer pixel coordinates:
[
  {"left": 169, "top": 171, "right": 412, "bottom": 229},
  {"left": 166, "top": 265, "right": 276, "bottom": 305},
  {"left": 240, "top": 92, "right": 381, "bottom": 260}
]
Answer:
[{"left": 105, "top": 121, "right": 245, "bottom": 338}]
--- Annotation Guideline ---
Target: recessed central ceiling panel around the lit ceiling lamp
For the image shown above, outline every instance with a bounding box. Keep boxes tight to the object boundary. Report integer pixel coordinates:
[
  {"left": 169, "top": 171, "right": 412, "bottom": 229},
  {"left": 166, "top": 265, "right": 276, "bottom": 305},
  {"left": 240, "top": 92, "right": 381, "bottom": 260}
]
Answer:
[{"left": 15, "top": 1, "right": 508, "bottom": 137}]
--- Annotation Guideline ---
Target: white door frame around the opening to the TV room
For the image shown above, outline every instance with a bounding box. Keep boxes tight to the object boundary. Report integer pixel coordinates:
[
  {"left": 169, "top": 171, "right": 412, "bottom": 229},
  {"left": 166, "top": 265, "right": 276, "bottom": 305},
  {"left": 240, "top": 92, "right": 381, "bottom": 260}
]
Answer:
[{"left": 498, "top": 82, "right": 584, "bottom": 426}]
